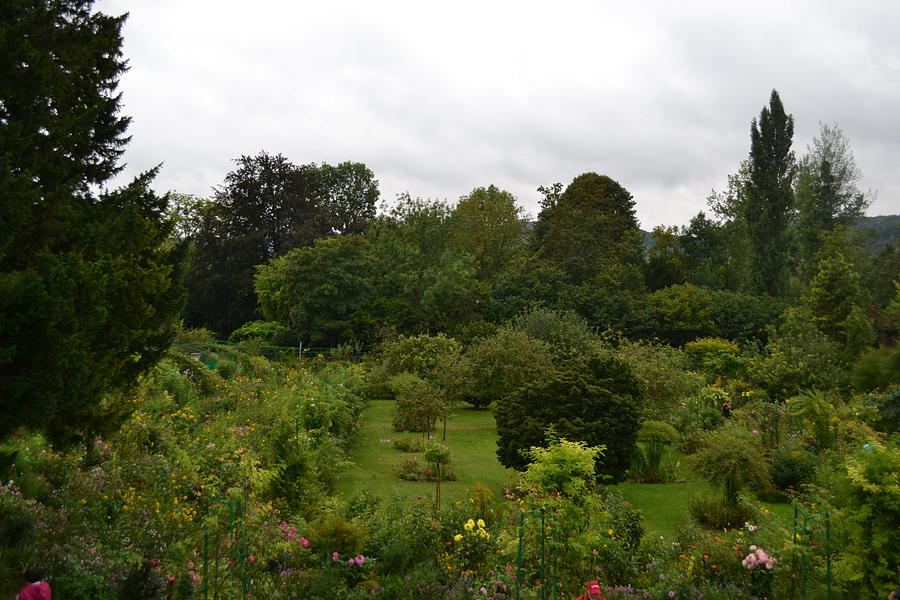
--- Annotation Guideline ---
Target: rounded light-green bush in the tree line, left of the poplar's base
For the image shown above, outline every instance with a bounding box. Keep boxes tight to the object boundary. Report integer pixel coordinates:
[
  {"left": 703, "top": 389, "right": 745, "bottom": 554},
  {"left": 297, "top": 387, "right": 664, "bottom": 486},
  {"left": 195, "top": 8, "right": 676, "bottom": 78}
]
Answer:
[{"left": 649, "top": 283, "right": 715, "bottom": 346}]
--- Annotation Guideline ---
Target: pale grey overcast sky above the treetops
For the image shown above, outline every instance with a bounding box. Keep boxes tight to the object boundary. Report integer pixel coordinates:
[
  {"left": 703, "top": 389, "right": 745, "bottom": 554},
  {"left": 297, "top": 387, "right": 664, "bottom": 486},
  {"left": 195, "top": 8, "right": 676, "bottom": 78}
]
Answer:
[{"left": 96, "top": 0, "right": 900, "bottom": 229}]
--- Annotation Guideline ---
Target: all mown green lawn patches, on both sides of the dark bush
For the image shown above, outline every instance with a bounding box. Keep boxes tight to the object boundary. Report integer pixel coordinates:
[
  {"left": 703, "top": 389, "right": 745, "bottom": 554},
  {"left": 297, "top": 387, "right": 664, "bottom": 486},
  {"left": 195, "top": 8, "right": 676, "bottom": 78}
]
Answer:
[{"left": 337, "top": 400, "right": 793, "bottom": 538}]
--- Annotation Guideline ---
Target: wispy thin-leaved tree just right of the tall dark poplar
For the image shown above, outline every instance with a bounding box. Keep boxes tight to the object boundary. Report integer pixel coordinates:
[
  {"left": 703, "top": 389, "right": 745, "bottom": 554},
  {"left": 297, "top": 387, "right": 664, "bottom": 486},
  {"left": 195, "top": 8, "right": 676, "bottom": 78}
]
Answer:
[{"left": 795, "top": 123, "right": 870, "bottom": 272}]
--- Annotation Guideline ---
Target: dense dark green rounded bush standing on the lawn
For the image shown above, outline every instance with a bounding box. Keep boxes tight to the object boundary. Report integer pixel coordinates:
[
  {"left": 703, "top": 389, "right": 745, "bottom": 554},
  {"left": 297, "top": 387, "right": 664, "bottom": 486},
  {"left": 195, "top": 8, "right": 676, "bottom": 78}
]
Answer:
[{"left": 494, "top": 353, "right": 639, "bottom": 482}]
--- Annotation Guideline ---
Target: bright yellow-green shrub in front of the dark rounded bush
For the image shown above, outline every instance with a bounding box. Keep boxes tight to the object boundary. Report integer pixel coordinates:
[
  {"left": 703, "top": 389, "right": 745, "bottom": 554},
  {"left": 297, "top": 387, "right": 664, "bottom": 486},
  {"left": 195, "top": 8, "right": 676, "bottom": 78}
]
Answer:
[{"left": 522, "top": 438, "right": 606, "bottom": 498}]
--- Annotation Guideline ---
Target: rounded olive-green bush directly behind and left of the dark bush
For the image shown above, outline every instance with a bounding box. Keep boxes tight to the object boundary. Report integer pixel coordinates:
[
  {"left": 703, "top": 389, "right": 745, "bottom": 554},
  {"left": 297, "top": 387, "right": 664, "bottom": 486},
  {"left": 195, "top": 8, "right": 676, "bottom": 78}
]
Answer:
[{"left": 465, "top": 327, "right": 553, "bottom": 408}]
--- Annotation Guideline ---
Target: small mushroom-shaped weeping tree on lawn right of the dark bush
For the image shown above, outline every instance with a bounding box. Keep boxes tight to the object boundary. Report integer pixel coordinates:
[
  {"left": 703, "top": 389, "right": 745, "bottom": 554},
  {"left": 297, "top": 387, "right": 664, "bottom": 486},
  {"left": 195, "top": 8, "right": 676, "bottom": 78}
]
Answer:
[{"left": 691, "top": 424, "right": 769, "bottom": 507}]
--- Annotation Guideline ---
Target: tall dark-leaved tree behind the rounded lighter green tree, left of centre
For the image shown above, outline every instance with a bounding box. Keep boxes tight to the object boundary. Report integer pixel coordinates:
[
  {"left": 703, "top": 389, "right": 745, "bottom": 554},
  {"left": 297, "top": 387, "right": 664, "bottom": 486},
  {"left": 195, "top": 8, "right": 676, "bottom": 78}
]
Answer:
[{"left": 186, "top": 152, "right": 378, "bottom": 335}]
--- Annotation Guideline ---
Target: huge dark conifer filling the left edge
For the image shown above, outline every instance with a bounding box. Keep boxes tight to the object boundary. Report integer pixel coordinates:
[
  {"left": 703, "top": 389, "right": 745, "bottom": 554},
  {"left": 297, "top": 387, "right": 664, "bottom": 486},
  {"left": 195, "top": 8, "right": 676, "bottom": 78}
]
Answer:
[{"left": 0, "top": 0, "right": 184, "bottom": 442}]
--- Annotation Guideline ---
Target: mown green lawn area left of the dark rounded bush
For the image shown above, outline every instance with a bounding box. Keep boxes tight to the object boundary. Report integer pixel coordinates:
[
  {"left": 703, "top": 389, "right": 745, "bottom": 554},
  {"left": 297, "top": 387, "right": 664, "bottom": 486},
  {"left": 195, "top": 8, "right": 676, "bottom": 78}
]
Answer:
[{"left": 337, "top": 400, "right": 515, "bottom": 502}]
